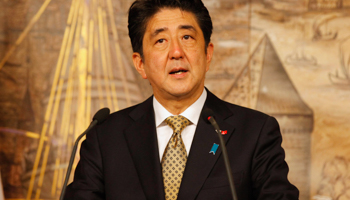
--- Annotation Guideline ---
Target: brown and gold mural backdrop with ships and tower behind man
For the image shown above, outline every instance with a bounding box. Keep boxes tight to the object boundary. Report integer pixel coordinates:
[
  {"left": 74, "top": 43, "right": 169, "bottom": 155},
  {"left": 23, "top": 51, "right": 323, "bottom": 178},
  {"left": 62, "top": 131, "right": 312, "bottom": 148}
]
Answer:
[{"left": 0, "top": 0, "right": 350, "bottom": 200}]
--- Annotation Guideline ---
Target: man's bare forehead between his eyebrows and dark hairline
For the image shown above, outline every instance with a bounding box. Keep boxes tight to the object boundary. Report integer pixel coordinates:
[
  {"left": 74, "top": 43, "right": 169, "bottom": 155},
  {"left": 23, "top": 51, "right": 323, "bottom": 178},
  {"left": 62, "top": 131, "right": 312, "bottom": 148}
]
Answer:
[{"left": 146, "top": 8, "right": 200, "bottom": 32}]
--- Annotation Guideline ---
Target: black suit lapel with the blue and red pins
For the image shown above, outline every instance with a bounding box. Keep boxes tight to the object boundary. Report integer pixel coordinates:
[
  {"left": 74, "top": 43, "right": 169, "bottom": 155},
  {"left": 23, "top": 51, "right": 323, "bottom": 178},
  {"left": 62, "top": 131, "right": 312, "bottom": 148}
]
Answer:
[{"left": 178, "top": 91, "right": 234, "bottom": 200}]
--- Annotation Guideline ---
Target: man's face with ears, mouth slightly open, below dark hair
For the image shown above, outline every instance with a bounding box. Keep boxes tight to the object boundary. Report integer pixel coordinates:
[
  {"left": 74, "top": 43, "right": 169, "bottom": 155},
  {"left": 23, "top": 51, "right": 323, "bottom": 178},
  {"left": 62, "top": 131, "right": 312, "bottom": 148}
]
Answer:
[{"left": 133, "top": 9, "right": 214, "bottom": 102}]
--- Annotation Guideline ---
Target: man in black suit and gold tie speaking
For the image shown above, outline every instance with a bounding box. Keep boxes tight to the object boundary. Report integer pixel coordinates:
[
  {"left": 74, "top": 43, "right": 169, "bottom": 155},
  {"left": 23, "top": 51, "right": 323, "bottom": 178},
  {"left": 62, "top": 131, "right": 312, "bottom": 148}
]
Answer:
[{"left": 65, "top": 0, "right": 299, "bottom": 200}]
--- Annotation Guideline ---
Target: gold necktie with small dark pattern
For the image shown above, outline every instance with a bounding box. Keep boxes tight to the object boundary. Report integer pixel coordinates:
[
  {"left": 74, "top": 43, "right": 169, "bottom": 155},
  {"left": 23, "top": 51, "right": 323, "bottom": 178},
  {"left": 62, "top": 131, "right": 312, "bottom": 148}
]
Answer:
[{"left": 162, "top": 115, "right": 190, "bottom": 200}]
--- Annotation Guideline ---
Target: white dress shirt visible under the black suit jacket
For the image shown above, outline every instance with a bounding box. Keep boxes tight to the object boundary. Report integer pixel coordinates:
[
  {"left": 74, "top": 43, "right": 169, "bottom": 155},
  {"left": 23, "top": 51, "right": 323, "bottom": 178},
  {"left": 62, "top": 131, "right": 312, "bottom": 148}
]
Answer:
[{"left": 153, "top": 89, "right": 207, "bottom": 160}]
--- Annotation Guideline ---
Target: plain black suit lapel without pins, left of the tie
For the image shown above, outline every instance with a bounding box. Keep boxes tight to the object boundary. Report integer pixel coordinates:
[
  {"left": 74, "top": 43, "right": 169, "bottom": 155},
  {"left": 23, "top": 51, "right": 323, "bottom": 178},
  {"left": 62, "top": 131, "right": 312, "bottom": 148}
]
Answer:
[{"left": 125, "top": 97, "right": 165, "bottom": 200}]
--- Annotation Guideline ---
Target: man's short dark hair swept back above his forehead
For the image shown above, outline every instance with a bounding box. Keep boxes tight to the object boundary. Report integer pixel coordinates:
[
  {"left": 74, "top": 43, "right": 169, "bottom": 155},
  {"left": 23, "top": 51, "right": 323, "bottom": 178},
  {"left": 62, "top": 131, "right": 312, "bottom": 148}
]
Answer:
[{"left": 128, "top": 0, "right": 213, "bottom": 57}]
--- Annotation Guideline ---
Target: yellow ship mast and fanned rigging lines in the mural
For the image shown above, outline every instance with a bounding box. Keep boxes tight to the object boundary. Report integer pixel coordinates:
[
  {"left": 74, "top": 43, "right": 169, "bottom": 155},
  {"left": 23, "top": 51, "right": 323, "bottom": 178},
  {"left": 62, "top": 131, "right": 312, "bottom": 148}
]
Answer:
[{"left": 27, "top": 0, "right": 142, "bottom": 199}]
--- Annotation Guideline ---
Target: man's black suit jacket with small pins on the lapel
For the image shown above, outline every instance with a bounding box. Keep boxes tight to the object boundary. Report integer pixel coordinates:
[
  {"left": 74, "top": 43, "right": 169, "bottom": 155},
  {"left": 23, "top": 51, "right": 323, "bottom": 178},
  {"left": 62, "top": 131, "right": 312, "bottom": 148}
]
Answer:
[{"left": 65, "top": 92, "right": 299, "bottom": 200}]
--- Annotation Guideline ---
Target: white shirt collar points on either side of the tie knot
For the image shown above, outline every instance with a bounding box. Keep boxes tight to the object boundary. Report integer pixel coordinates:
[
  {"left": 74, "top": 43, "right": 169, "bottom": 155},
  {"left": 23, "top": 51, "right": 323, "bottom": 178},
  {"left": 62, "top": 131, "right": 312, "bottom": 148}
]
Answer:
[{"left": 153, "top": 89, "right": 207, "bottom": 127}]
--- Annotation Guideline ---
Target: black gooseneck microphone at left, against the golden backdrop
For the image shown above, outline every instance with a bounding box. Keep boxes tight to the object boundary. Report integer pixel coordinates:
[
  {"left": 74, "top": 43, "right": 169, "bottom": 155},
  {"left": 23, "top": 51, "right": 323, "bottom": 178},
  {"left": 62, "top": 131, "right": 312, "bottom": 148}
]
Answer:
[{"left": 60, "top": 108, "right": 110, "bottom": 200}]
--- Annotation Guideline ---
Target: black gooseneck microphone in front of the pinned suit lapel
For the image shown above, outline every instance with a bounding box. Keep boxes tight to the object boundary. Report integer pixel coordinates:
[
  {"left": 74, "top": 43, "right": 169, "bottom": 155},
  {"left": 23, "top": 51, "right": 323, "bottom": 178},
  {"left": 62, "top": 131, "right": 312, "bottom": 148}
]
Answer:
[{"left": 202, "top": 108, "right": 238, "bottom": 200}]
